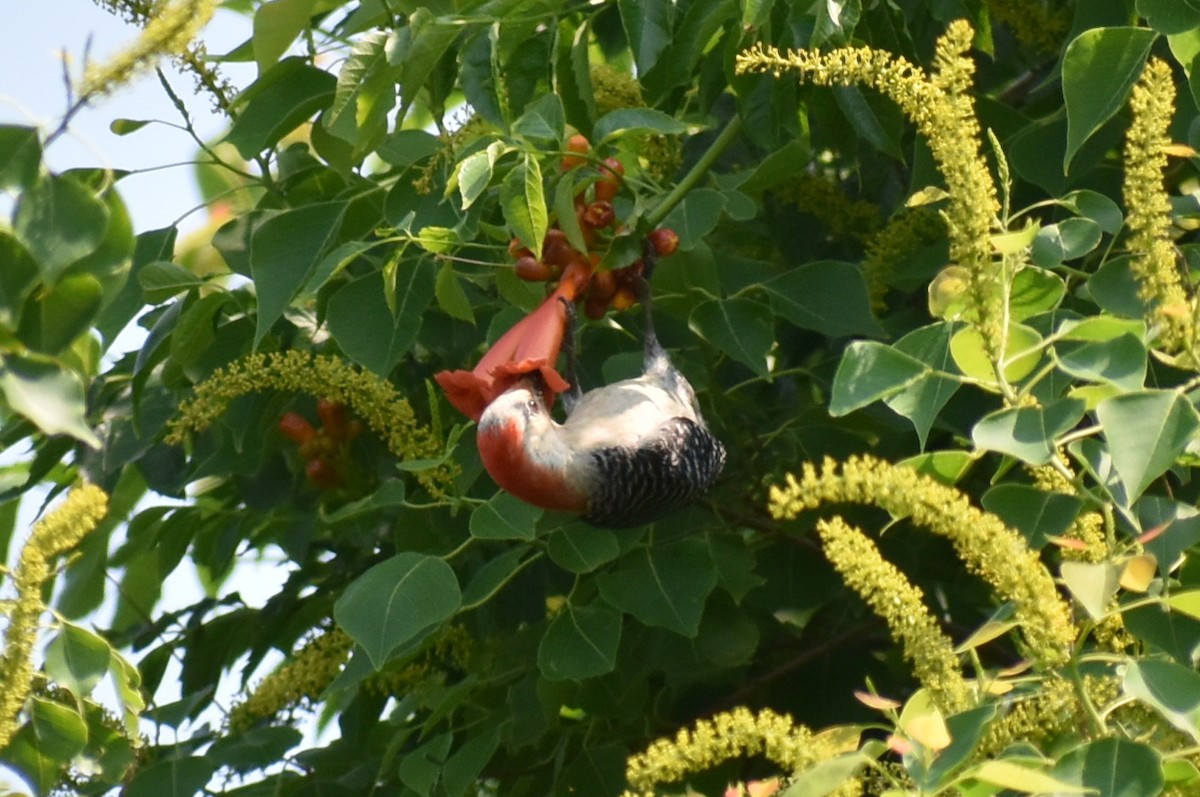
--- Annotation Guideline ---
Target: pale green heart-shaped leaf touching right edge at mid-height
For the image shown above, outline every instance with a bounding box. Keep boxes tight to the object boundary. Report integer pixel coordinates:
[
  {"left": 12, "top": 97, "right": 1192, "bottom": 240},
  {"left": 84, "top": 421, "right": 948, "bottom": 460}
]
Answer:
[{"left": 1096, "top": 390, "right": 1200, "bottom": 504}]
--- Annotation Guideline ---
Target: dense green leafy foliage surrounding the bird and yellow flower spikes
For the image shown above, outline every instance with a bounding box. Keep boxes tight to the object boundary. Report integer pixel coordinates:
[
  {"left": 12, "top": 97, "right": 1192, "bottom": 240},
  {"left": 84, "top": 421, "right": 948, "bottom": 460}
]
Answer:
[{"left": 0, "top": 0, "right": 1200, "bottom": 797}]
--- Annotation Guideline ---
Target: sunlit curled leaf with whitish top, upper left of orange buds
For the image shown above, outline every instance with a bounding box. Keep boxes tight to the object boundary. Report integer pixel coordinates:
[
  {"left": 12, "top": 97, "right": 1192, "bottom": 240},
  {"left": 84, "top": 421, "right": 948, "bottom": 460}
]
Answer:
[{"left": 322, "top": 30, "right": 400, "bottom": 150}]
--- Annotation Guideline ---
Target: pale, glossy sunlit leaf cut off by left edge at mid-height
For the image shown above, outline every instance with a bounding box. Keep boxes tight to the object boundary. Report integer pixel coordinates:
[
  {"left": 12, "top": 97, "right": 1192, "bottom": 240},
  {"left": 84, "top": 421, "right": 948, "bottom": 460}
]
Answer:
[{"left": 0, "top": 354, "right": 100, "bottom": 449}]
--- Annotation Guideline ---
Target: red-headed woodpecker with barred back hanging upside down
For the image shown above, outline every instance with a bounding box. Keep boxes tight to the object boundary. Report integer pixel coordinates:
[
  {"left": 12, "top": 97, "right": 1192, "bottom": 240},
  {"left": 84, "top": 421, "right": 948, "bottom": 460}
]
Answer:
[{"left": 476, "top": 266, "right": 725, "bottom": 528}]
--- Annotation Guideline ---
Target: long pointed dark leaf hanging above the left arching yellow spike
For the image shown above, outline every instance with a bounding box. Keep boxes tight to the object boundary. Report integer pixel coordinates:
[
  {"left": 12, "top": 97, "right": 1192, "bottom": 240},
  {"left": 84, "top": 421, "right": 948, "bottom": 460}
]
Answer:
[{"left": 250, "top": 202, "right": 346, "bottom": 346}]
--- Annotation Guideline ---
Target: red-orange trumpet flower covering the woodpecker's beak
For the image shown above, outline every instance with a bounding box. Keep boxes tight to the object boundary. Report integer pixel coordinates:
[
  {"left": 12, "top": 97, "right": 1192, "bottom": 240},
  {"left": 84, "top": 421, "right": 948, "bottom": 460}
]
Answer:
[{"left": 433, "top": 260, "right": 593, "bottom": 421}]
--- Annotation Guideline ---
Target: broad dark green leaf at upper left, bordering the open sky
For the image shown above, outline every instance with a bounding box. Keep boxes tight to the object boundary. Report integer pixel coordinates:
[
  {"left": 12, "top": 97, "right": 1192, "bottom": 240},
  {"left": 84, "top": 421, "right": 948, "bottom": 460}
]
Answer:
[{"left": 226, "top": 58, "right": 337, "bottom": 160}]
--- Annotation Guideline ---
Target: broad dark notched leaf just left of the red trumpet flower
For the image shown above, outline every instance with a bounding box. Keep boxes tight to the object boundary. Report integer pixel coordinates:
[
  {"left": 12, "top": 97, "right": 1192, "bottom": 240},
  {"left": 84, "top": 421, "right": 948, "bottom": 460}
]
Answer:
[{"left": 328, "top": 260, "right": 434, "bottom": 374}]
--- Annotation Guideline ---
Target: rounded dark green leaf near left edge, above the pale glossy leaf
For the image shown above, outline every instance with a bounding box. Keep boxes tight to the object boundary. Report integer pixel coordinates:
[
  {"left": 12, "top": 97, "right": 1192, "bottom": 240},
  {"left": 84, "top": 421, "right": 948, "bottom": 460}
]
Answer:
[{"left": 12, "top": 175, "right": 108, "bottom": 282}]
